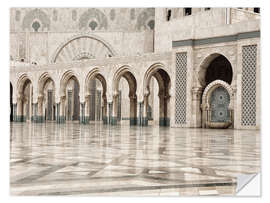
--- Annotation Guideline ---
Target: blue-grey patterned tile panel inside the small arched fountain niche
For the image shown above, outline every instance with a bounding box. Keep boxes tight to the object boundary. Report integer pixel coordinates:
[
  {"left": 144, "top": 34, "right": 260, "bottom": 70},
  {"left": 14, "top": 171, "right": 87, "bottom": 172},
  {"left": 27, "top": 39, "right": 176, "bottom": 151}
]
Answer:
[{"left": 210, "top": 86, "right": 230, "bottom": 122}]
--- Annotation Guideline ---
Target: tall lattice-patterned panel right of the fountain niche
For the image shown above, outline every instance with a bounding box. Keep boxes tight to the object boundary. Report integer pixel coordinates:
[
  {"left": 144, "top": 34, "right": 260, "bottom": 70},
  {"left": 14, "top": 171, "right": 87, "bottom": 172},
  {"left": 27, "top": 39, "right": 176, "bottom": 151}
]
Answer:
[{"left": 241, "top": 45, "right": 257, "bottom": 126}]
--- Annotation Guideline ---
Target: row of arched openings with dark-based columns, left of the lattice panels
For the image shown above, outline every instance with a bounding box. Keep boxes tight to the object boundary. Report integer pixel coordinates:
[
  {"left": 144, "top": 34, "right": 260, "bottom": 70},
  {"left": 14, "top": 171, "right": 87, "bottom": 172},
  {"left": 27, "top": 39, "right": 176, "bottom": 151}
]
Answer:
[{"left": 10, "top": 66, "right": 173, "bottom": 126}]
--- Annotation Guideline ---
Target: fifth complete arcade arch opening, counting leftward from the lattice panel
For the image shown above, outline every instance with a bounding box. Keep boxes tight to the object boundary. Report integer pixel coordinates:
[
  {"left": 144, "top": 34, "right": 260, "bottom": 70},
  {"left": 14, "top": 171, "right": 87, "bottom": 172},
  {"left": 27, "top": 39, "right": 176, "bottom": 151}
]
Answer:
[{"left": 38, "top": 73, "right": 56, "bottom": 121}]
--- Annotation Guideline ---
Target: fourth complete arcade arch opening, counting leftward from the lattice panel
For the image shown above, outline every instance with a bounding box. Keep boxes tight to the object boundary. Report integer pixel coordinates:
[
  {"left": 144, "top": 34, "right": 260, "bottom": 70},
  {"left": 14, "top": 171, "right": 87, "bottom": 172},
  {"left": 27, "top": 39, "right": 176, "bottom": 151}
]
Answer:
[{"left": 60, "top": 71, "right": 80, "bottom": 122}]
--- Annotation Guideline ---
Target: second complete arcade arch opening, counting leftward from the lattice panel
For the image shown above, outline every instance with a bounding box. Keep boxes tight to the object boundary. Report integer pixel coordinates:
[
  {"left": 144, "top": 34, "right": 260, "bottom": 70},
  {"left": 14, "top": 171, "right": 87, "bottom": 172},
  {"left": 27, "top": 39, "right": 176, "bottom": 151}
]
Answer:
[{"left": 111, "top": 67, "right": 137, "bottom": 125}]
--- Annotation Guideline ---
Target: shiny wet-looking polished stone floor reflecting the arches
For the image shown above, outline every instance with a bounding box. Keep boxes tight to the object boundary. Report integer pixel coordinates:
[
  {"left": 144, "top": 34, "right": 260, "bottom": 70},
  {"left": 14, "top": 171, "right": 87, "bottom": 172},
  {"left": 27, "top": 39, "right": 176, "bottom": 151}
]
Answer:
[{"left": 10, "top": 123, "right": 260, "bottom": 196}]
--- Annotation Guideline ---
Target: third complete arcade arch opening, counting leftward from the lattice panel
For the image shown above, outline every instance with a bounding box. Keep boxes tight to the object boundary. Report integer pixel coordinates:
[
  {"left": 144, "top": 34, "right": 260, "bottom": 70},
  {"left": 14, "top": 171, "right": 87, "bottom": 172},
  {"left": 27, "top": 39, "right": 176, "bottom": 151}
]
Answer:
[{"left": 85, "top": 69, "right": 108, "bottom": 124}]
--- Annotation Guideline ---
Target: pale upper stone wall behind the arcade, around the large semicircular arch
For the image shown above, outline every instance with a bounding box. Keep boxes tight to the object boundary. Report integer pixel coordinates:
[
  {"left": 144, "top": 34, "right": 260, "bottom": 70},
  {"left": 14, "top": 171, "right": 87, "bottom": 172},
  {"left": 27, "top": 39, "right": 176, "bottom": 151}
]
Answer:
[{"left": 10, "top": 8, "right": 155, "bottom": 65}]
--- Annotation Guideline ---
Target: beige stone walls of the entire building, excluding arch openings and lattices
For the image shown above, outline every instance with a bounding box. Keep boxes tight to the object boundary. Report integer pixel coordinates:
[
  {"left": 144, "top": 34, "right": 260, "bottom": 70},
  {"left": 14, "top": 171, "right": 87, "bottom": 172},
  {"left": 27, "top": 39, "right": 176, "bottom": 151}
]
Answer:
[{"left": 10, "top": 8, "right": 260, "bottom": 129}]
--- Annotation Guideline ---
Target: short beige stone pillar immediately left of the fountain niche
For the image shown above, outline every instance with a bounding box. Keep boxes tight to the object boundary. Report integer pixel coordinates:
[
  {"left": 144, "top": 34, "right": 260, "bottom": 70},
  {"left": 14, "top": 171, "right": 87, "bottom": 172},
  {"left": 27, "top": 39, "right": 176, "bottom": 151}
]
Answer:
[{"left": 191, "top": 87, "right": 202, "bottom": 128}]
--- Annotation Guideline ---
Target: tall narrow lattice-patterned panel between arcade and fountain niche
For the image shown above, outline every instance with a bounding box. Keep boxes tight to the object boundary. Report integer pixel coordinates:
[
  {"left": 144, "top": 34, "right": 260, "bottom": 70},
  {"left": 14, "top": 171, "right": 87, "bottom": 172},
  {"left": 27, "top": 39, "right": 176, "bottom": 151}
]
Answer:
[{"left": 175, "top": 52, "right": 187, "bottom": 124}]
